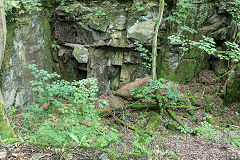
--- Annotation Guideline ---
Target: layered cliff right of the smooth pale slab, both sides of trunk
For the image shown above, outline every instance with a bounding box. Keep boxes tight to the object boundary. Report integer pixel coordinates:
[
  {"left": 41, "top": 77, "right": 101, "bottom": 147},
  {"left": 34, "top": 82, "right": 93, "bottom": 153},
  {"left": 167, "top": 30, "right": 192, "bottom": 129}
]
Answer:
[{"left": 54, "top": 0, "right": 236, "bottom": 92}]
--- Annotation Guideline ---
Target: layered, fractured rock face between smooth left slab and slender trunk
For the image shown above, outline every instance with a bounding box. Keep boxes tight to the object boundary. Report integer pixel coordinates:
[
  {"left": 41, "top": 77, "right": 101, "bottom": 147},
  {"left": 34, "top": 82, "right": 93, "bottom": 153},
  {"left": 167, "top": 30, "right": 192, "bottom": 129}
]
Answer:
[{"left": 54, "top": 1, "right": 189, "bottom": 92}]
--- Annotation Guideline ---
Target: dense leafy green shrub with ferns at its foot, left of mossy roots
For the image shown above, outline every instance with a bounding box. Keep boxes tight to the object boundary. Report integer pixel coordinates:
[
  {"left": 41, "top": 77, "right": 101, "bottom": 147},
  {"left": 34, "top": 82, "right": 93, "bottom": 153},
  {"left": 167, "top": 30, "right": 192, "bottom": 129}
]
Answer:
[{"left": 20, "top": 65, "right": 119, "bottom": 148}]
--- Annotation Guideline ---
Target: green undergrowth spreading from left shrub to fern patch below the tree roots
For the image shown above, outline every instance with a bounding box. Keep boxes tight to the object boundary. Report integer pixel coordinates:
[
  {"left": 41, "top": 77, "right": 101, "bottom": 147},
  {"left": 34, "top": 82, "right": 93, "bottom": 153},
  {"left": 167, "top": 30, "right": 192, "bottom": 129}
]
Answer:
[{"left": 4, "top": 65, "right": 157, "bottom": 159}]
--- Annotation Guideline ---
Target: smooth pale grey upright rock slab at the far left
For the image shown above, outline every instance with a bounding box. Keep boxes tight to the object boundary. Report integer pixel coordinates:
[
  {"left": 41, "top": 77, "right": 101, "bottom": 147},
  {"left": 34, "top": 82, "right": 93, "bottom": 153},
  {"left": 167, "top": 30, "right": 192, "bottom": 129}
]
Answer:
[{"left": 0, "top": 11, "right": 53, "bottom": 108}]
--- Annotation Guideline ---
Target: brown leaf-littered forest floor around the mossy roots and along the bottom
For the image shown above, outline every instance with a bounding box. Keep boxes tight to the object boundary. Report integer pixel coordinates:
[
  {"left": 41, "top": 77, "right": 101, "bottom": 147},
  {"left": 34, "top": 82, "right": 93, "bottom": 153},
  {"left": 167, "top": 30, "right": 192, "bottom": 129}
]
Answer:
[{"left": 0, "top": 70, "right": 240, "bottom": 160}]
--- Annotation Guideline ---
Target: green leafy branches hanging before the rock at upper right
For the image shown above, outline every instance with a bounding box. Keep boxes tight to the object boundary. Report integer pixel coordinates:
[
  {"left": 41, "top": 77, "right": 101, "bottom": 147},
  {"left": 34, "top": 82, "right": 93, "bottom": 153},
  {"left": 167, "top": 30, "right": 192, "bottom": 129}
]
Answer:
[{"left": 166, "top": 0, "right": 240, "bottom": 80}]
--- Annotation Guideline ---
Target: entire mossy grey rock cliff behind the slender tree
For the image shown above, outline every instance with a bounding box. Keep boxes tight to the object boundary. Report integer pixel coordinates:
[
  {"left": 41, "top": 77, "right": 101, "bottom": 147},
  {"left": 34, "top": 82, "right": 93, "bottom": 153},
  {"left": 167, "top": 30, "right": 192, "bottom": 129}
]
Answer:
[{"left": 1, "top": 0, "right": 240, "bottom": 107}]
